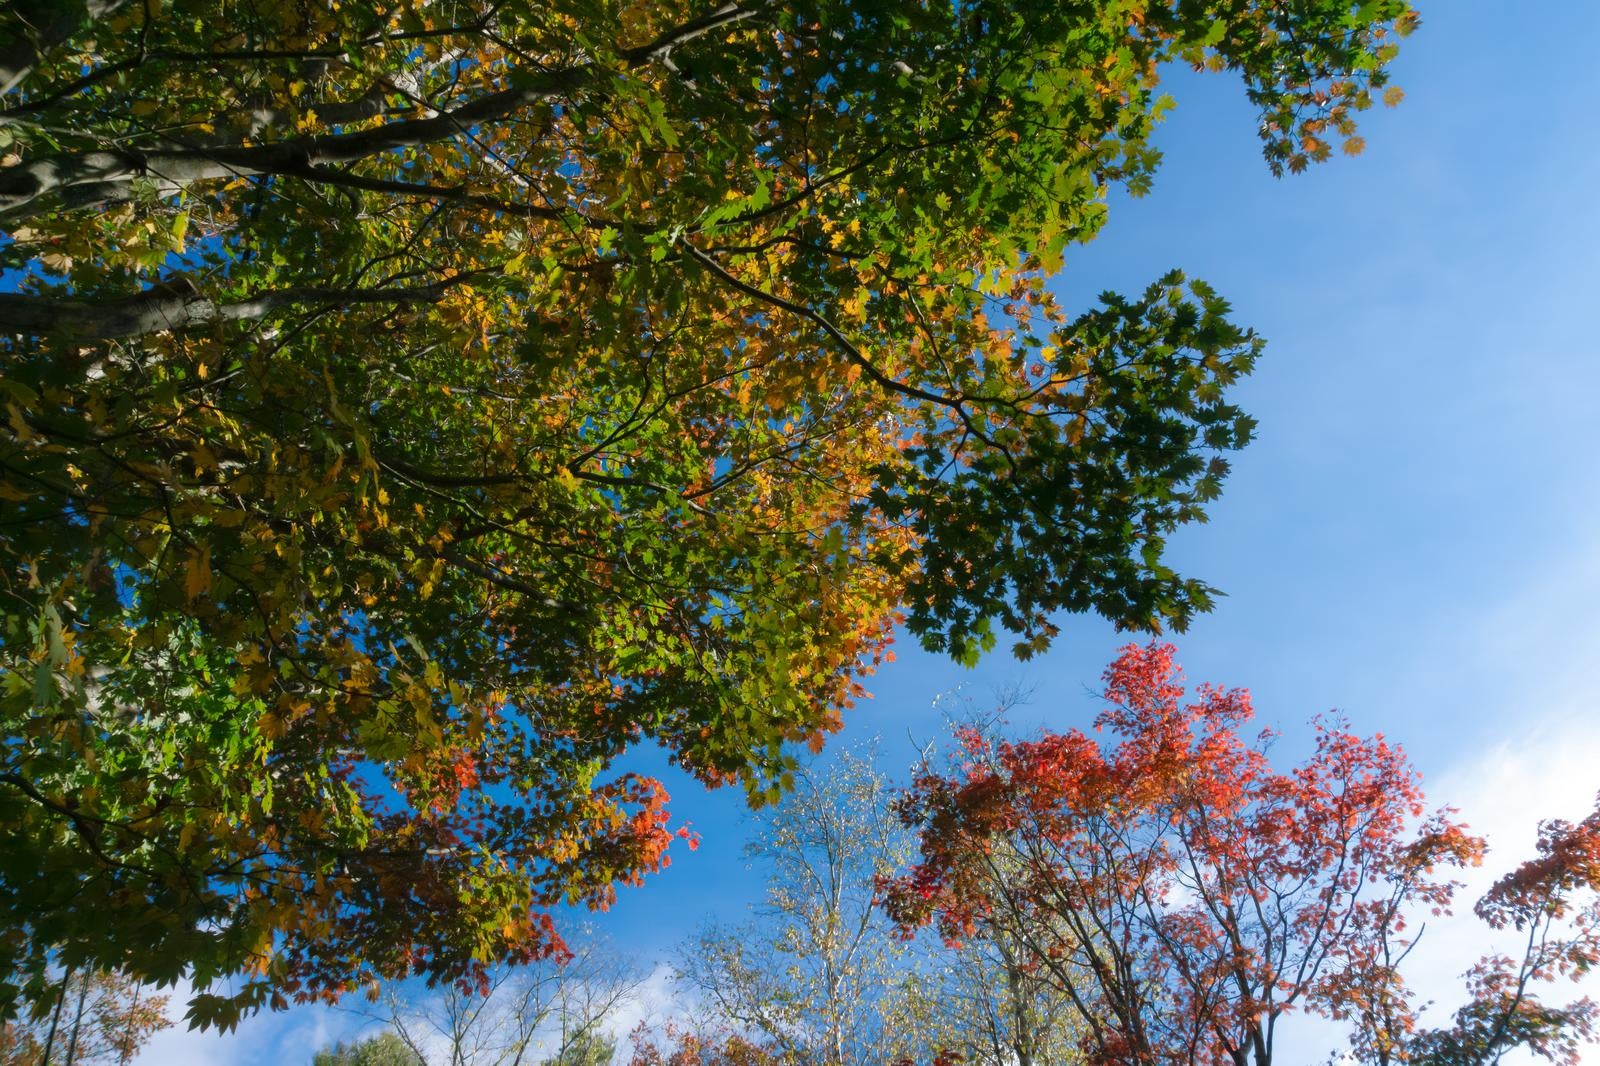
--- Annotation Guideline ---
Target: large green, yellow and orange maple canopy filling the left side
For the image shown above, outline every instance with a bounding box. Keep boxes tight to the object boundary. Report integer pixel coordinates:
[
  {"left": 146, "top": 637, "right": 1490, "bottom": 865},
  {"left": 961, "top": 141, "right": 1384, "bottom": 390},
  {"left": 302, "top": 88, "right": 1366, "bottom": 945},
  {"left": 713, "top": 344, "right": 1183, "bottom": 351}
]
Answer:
[{"left": 0, "top": 0, "right": 1414, "bottom": 1024}]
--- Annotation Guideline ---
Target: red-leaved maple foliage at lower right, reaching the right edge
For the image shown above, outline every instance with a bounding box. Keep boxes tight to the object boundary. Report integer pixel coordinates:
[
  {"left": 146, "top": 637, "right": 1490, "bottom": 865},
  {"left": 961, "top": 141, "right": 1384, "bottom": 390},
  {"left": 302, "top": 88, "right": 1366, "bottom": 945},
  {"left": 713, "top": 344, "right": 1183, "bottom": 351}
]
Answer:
[{"left": 880, "top": 645, "right": 1600, "bottom": 1066}]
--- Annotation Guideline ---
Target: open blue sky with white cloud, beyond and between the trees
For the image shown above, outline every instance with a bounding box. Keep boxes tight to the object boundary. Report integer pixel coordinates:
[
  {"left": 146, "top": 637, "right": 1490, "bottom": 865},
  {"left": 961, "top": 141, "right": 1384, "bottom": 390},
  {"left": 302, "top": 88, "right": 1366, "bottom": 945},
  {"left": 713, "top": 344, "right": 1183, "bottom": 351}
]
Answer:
[{"left": 141, "top": 0, "right": 1600, "bottom": 1063}]
